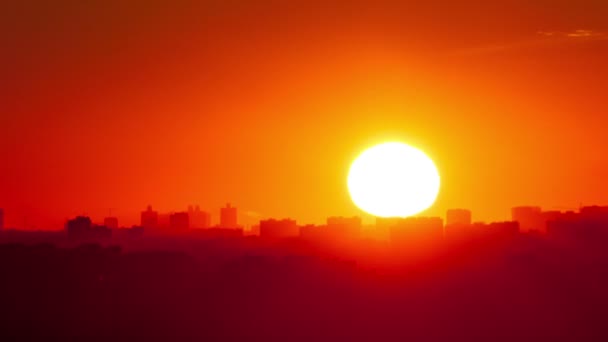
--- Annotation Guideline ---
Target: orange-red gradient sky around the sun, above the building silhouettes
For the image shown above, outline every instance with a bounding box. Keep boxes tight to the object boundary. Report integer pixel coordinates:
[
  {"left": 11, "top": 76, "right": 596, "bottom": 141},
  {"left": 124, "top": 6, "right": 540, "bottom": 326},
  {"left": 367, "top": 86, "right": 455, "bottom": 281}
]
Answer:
[{"left": 0, "top": 0, "right": 608, "bottom": 228}]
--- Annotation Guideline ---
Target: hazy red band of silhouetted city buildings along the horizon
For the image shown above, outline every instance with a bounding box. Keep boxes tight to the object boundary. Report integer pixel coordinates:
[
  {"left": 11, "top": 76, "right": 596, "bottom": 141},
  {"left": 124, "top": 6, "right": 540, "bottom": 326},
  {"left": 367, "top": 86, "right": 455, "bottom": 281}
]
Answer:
[{"left": 0, "top": 203, "right": 608, "bottom": 244}]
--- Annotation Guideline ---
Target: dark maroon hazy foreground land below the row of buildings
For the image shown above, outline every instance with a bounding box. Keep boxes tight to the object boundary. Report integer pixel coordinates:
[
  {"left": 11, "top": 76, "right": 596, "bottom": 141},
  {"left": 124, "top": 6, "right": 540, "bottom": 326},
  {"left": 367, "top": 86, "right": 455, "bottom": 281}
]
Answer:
[{"left": 0, "top": 231, "right": 608, "bottom": 341}]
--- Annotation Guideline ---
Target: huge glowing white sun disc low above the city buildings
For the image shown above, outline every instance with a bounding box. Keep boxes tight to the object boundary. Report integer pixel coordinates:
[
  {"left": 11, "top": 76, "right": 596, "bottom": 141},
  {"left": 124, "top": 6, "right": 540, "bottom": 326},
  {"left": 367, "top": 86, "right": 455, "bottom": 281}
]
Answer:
[{"left": 348, "top": 142, "right": 440, "bottom": 217}]
